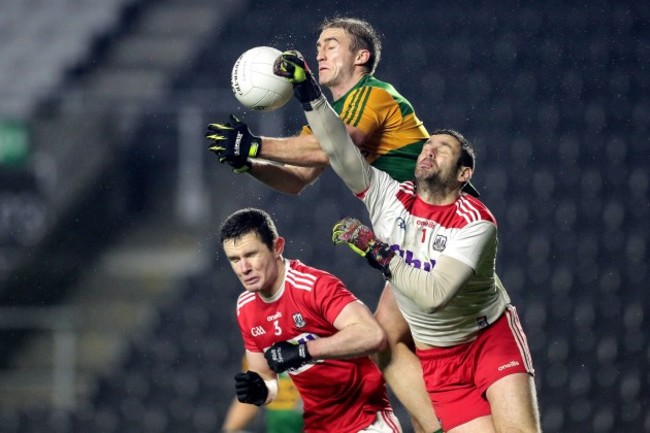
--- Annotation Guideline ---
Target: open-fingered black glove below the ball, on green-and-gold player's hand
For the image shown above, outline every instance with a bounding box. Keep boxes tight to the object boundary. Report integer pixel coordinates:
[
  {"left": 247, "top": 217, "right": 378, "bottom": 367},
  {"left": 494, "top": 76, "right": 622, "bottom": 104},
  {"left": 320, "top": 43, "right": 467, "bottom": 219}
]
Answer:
[{"left": 205, "top": 114, "right": 262, "bottom": 173}]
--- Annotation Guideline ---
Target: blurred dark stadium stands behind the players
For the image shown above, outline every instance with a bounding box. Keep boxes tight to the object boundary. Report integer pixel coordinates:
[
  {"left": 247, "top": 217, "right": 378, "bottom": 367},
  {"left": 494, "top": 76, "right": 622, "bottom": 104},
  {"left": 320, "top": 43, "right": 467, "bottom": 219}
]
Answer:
[{"left": 0, "top": 0, "right": 650, "bottom": 433}]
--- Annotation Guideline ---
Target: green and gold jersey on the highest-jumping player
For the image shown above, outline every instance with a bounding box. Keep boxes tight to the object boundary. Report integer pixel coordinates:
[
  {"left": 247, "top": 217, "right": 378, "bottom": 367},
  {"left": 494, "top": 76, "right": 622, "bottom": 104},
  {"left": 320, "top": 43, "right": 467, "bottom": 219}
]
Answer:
[{"left": 302, "top": 75, "right": 429, "bottom": 182}]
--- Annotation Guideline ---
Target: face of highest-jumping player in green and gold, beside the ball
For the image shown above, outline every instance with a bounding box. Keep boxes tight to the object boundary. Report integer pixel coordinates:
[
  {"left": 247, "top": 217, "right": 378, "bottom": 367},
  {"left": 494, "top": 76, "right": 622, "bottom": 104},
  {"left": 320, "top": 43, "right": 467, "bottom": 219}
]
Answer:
[{"left": 316, "top": 28, "right": 355, "bottom": 87}]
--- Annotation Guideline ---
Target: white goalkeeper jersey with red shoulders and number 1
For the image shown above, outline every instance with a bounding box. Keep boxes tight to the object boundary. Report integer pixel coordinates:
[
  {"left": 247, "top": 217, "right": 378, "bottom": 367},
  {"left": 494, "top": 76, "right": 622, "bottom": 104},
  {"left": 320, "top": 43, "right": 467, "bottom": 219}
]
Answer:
[{"left": 358, "top": 168, "right": 510, "bottom": 347}]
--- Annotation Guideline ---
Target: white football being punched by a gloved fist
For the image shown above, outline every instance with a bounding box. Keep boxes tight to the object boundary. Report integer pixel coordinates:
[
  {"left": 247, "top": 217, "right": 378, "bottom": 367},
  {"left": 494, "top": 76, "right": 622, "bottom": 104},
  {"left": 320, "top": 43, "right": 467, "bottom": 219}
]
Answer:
[{"left": 230, "top": 46, "right": 293, "bottom": 111}]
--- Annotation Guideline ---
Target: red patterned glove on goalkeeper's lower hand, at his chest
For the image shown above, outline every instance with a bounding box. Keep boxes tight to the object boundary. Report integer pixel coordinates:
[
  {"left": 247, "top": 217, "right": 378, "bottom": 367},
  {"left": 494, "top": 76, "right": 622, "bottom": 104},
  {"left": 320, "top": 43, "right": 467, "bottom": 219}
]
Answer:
[{"left": 332, "top": 217, "right": 395, "bottom": 278}]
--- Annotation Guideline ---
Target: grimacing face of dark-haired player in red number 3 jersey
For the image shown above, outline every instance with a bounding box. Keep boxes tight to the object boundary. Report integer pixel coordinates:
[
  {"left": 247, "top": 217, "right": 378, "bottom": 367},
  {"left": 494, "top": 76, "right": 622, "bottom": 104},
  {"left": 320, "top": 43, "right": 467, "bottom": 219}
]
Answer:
[{"left": 223, "top": 232, "right": 284, "bottom": 296}]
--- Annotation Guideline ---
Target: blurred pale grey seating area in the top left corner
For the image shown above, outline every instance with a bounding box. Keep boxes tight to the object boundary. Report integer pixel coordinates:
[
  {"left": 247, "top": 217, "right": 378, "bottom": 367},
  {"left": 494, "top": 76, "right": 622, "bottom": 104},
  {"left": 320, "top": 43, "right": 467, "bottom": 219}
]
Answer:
[{"left": 0, "top": 0, "right": 136, "bottom": 119}]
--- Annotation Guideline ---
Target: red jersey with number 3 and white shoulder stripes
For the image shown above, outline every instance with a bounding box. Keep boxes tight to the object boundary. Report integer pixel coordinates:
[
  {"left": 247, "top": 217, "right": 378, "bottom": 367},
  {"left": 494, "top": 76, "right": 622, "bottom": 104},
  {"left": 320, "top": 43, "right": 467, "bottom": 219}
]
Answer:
[{"left": 237, "top": 260, "right": 390, "bottom": 433}]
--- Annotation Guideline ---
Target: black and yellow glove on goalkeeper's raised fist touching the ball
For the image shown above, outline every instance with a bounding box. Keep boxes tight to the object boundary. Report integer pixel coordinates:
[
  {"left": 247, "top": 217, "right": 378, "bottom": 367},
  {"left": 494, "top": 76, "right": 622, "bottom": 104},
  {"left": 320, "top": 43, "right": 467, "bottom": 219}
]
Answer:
[{"left": 273, "top": 50, "right": 323, "bottom": 111}]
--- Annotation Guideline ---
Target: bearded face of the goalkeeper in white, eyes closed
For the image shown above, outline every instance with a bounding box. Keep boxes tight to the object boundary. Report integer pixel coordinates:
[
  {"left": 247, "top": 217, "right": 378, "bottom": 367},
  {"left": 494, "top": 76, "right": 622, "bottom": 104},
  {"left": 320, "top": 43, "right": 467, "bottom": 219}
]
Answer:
[{"left": 415, "top": 134, "right": 461, "bottom": 187}]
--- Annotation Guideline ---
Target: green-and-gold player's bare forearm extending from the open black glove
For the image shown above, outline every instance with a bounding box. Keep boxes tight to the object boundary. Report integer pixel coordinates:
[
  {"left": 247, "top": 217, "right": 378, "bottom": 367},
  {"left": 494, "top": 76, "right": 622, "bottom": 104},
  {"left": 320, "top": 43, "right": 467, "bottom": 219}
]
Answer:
[{"left": 259, "top": 135, "right": 329, "bottom": 167}]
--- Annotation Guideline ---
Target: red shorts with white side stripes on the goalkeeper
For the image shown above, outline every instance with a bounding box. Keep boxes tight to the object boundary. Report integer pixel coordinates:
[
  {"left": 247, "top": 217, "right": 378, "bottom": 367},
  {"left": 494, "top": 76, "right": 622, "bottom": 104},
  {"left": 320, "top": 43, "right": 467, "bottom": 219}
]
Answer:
[{"left": 416, "top": 306, "right": 534, "bottom": 431}]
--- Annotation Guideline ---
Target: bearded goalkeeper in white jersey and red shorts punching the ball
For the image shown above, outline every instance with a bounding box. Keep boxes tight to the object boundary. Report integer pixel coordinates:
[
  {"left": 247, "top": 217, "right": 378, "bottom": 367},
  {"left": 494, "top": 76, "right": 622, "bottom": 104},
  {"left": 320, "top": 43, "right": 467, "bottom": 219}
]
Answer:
[{"left": 275, "top": 51, "right": 540, "bottom": 433}]
